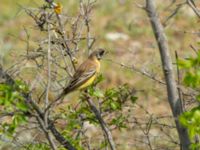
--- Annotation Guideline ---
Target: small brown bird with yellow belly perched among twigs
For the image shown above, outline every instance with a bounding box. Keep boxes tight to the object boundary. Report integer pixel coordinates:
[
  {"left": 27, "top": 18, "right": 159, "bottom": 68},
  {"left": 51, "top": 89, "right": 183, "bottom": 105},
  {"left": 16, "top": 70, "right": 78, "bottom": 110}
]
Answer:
[{"left": 57, "top": 48, "right": 105, "bottom": 99}]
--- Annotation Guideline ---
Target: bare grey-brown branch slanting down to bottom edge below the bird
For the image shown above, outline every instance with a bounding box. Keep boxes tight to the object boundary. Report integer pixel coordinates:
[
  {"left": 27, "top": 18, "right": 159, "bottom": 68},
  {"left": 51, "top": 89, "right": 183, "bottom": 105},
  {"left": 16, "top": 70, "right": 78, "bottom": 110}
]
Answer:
[{"left": 86, "top": 97, "right": 116, "bottom": 150}]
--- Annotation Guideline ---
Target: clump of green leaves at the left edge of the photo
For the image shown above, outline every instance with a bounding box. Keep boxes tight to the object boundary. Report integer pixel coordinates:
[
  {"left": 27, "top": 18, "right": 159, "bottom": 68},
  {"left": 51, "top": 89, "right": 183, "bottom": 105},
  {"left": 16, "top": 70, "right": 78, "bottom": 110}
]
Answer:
[{"left": 0, "top": 81, "right": 28, "bottom": 137}]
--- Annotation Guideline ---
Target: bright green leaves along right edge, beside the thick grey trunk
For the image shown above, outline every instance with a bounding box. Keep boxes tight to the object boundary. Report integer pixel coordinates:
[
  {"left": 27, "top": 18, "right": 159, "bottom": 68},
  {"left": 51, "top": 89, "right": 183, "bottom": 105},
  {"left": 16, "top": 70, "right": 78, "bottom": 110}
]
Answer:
[{"left": 178, "top": 51, "right": 200, "bottom": 150}]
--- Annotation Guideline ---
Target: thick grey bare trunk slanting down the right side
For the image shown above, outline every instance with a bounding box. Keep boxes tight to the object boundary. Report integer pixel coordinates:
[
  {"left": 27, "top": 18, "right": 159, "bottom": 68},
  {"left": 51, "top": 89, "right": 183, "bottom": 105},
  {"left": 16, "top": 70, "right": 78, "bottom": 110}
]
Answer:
[{"left": 146, "top": 0, "right": 190, "bottom": 150}]
